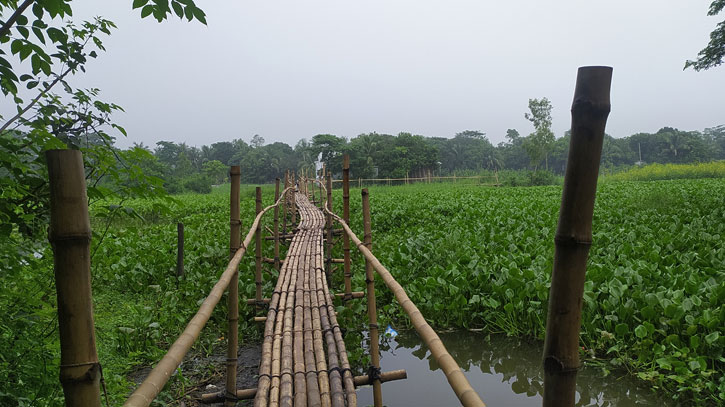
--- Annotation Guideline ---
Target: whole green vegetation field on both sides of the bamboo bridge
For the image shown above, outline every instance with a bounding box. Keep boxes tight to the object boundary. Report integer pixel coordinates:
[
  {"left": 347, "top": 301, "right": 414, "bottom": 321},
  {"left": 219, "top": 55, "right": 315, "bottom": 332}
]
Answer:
[{"left": 0, "top": 179, "right": 725, "bottom": 405}]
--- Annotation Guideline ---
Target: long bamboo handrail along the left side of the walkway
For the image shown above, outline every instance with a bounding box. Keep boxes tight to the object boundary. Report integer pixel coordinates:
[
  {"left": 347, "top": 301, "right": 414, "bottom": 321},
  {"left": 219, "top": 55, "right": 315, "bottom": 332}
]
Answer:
[{"left": 123, "top": 187, "right": 292, "bottom": 407}]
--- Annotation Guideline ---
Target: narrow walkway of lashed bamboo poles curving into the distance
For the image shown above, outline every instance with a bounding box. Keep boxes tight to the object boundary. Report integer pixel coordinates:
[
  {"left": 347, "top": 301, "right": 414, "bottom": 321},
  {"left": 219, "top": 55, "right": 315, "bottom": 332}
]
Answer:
[{"left": 254, "top": 193, "right": 357, "bottom": 407}]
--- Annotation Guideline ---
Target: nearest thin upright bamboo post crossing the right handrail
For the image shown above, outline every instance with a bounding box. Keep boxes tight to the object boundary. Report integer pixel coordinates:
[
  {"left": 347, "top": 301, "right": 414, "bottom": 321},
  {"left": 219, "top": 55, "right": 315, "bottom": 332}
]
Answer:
[{"left": 362, "top": 188, "right": 383, "bottom": 407}]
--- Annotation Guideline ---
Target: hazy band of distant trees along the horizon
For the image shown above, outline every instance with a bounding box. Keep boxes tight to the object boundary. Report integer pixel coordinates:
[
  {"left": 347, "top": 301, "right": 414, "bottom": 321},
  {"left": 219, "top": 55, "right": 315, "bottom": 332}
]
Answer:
[{"left": 143, "top": 125, "right": 725, "bottom": 193}]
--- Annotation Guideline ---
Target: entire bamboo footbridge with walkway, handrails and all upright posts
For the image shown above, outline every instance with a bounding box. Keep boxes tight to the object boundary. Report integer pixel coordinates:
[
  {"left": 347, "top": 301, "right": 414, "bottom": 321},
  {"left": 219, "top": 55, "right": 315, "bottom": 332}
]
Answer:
[{"left": 46, "top": 67, "right": 612, "bottom": 407}]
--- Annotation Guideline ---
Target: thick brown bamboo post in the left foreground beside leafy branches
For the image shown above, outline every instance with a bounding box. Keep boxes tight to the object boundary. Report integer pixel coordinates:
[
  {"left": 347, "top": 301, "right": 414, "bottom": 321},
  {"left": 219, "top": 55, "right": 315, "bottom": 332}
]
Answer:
[{"left": 45, "top": 150, "right": 101, "bottom": 407}]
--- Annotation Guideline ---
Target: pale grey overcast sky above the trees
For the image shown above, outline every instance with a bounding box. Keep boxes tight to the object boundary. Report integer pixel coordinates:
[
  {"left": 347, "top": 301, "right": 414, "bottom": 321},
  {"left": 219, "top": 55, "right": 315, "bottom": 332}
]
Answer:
[{"left": 63, "top": 0, "right": 725, "bottom": 147}]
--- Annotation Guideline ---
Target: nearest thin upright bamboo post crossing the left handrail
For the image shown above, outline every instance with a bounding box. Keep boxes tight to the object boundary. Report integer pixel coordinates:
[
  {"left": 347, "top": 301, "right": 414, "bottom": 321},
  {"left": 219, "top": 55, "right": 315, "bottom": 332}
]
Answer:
[{"left": 224, "top": 165, "right": 242, "bottom": 406}]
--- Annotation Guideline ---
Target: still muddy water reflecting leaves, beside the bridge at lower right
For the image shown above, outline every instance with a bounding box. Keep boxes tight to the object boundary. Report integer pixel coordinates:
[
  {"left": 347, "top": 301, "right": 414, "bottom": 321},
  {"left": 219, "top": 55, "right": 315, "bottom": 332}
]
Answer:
[{"left": 357, "top": 332, "right": 675, "bottom": 407}]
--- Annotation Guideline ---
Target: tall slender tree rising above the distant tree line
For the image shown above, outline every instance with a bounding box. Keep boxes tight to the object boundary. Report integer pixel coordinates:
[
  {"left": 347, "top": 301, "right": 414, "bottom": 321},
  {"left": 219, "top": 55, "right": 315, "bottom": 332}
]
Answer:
[{"left": 523, "top": 98, "right": 555, "bottom": 172}]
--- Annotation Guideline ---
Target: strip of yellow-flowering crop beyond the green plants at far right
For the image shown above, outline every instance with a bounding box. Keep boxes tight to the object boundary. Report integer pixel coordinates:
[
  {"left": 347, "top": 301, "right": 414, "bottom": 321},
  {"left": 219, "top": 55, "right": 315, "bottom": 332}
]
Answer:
[{"left": 604, "top": 161, "right": 725, "bottom": 181}]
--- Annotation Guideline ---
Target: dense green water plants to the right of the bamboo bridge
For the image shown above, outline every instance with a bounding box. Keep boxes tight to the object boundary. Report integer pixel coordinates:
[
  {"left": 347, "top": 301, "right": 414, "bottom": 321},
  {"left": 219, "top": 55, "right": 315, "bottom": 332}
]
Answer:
[{"left": 336, "top": 179, "right": 725, "bottom": 405}]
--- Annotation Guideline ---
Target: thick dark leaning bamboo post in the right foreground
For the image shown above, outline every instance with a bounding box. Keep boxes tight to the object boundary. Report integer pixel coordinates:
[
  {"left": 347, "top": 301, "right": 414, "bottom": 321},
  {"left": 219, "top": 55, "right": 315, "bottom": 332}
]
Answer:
[{"left": 543, "top": 66, "right": 612, "bottom": 407}]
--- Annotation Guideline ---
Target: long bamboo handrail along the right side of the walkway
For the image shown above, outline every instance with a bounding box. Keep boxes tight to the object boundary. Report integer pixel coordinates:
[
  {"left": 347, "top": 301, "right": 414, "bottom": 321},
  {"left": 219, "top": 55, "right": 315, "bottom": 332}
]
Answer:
[{"left": 314, "top": 180, "right": 486, "bottom": 407}]
